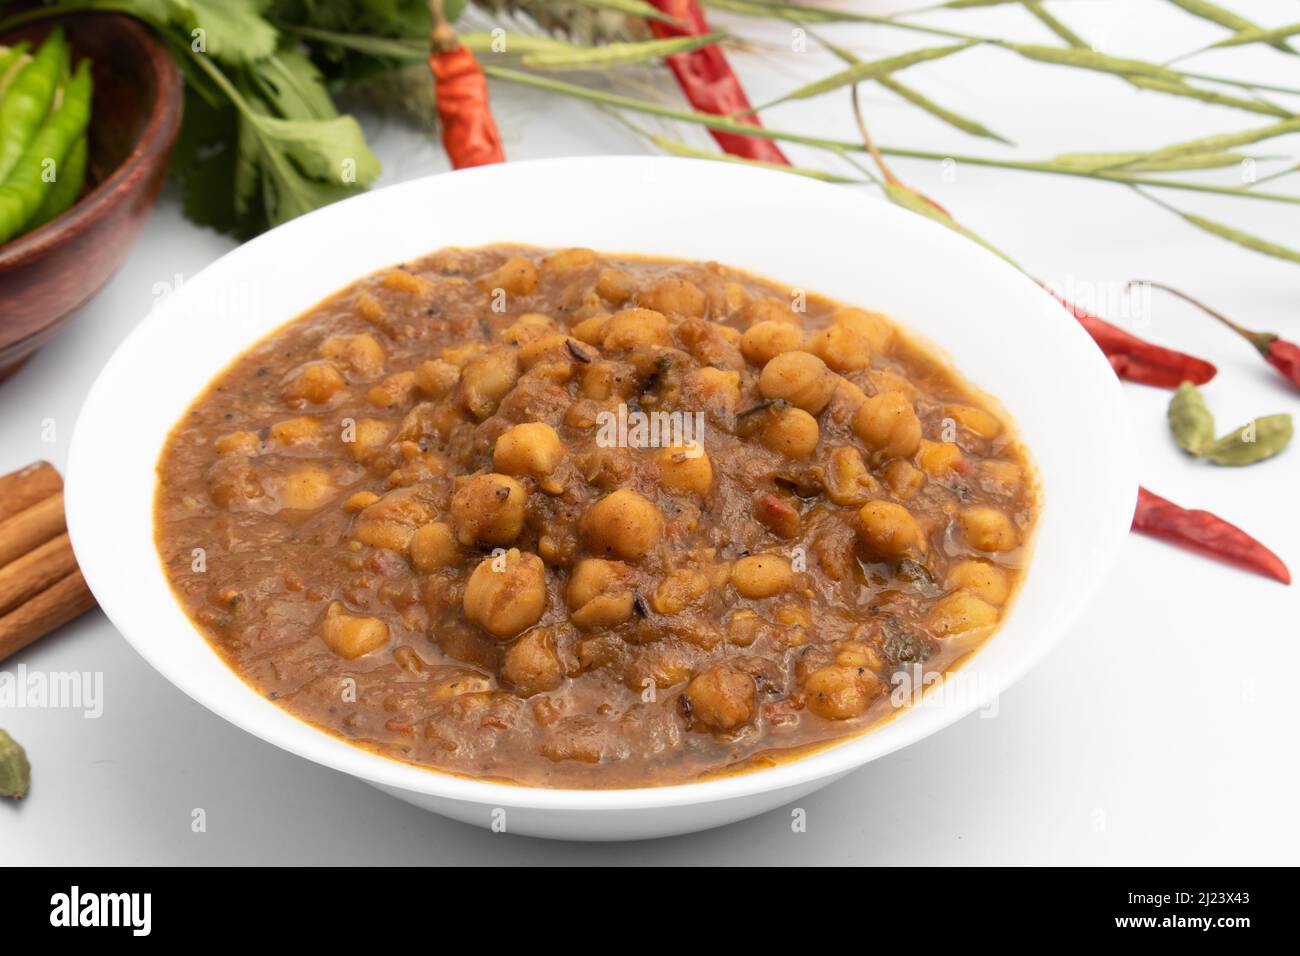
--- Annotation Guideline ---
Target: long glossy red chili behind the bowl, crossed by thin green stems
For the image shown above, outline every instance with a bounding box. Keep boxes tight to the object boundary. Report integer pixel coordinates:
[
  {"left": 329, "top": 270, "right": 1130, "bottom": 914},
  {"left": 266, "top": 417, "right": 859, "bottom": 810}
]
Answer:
[{"left": 649, "top": 0, "right": 790, "bottom": 166}]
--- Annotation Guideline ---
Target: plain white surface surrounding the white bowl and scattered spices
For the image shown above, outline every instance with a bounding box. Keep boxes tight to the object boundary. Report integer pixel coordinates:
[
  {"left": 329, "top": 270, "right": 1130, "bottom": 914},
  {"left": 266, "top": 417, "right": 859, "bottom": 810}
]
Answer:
[{"left": 0, "top": 0, "right": 1300, "bottom": 864}]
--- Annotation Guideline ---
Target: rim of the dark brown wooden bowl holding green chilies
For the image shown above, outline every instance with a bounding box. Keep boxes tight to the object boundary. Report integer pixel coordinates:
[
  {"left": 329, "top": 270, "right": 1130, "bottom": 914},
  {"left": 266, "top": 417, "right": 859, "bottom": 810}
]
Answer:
[{"left": 0, "top": 10, "right": 183, "bottom": 273}]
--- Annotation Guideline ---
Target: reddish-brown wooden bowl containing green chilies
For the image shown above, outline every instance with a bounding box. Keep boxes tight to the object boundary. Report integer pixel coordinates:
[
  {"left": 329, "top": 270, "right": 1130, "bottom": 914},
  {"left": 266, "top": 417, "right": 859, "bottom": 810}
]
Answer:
[{"left": 0, "top": 13, "right": 183, "bottom": 380}]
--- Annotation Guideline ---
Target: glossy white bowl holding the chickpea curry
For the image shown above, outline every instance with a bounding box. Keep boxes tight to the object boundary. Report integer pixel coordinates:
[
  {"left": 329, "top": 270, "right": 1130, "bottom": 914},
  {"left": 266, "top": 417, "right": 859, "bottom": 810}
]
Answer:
[{"left": 65, "top": 157, "right": 1136, "bottom": 840}]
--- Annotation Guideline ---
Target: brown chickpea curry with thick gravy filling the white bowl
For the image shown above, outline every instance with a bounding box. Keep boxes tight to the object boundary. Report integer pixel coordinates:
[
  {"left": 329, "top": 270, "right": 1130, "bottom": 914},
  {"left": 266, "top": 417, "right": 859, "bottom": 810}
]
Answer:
[{"left": 156, "top": 246, "right": 1036, "bottom": 787}]
